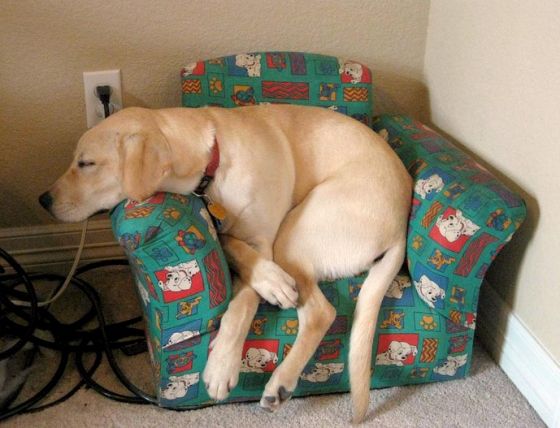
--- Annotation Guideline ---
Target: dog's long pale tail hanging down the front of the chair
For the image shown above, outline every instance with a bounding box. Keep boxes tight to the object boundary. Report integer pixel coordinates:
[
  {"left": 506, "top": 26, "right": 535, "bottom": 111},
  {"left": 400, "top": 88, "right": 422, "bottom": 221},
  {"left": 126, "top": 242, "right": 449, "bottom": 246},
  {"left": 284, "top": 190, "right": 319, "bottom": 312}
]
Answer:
[{"left": 348, "top": 238, "right": 406, "bottom": 423}]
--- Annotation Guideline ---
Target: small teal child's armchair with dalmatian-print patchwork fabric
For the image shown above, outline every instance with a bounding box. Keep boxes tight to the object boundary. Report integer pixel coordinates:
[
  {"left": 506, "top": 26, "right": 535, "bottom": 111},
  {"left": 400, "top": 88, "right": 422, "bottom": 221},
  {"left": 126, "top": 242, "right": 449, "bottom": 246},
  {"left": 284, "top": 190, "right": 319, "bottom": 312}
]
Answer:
[{"left": 109, "top": 53, "right": 526, "bottom": 408}]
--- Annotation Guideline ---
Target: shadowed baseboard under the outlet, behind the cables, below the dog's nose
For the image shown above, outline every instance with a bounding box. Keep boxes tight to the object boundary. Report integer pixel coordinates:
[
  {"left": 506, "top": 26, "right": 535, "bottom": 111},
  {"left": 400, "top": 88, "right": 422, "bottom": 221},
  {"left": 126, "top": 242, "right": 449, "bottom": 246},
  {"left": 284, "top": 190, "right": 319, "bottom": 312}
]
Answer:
[{"left": 0, "top": 220, "right": 124, "bottom": 273}]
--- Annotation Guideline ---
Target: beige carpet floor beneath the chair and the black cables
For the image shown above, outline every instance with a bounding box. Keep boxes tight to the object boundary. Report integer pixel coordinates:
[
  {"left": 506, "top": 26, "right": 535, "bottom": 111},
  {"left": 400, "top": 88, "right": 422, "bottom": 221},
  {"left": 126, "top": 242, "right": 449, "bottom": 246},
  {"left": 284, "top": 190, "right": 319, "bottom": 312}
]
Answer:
[{"left": 2, "top": 268, "right": 545, "bottom": 428}]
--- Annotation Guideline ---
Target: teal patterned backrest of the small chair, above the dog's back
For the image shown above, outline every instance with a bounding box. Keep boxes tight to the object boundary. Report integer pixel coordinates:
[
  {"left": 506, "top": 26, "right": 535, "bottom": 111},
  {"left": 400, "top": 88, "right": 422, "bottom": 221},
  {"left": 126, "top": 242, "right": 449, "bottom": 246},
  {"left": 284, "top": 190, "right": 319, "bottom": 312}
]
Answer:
[{"left": 181, "top": 52, "right": 373, "bottom": 126}]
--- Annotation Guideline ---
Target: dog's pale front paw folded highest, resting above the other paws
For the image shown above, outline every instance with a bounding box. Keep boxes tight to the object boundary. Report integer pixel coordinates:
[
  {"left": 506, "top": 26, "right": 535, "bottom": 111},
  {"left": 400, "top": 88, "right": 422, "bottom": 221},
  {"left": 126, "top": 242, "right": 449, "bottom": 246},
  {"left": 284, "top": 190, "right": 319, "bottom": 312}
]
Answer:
[{"left": 251, "top": 260, "right": 298, "bottom": 309}]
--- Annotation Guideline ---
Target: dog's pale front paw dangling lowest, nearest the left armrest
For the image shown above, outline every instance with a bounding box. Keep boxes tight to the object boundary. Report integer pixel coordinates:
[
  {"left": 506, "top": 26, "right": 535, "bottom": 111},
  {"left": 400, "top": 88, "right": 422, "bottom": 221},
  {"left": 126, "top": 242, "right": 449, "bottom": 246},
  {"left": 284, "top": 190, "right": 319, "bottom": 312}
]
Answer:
[{"left": 202, "top": 340, "right": 241, "bottom": 401}]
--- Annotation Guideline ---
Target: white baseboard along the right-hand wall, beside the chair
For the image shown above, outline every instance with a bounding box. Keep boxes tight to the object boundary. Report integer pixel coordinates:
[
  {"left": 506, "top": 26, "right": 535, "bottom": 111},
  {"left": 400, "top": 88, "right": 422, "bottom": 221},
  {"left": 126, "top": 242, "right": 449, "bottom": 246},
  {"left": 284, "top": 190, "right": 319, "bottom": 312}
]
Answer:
[{"left": 477, "top": 283, "right": 560, "bottom": 428}]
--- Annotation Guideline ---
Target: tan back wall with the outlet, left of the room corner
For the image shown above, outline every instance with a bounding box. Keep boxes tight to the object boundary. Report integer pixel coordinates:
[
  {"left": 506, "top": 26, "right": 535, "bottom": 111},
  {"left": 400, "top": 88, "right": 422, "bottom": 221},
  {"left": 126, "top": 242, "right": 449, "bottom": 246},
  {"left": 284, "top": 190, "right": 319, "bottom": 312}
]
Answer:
[{"left": 0, "top": 0, "right": 429, "bottom": 228}]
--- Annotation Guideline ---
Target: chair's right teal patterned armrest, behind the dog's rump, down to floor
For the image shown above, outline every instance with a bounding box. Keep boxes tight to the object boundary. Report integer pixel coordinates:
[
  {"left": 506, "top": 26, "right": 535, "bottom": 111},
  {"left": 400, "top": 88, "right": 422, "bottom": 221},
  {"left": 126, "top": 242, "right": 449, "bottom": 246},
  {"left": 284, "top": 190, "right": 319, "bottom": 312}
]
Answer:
[{"left": 373, "top": 115, "right": 526, "bottom": 386}]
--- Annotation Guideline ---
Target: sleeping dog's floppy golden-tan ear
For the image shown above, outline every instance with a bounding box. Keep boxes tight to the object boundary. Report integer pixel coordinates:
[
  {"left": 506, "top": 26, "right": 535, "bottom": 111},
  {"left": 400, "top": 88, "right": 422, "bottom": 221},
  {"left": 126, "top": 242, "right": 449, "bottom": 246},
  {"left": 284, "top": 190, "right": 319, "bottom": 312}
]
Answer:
[{"left": 120, "top": 133, "right": 171, "bottom": 201}]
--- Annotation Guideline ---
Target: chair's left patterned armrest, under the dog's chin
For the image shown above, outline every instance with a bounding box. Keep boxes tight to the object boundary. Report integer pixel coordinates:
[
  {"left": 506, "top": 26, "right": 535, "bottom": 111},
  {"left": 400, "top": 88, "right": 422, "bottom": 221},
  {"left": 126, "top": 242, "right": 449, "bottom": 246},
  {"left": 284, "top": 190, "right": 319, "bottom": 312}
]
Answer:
[{"left": 111, "top": 193, "right": 232, "bottom": 406}]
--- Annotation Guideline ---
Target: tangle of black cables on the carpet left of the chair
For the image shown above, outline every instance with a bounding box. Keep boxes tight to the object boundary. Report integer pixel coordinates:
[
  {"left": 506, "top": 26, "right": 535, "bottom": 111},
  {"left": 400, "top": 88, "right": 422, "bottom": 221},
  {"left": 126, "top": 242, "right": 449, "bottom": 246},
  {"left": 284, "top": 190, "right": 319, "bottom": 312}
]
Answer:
[{"left": 0, "top": 248, "right": 157, "bottom": 421}]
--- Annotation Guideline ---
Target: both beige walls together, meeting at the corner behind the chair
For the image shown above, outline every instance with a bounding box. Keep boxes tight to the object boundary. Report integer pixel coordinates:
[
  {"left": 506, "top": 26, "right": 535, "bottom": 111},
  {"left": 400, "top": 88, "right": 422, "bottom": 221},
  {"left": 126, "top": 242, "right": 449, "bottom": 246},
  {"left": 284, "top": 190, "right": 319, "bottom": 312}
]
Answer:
[{"left": 0, "top": 0, "right": 560, "bottom": 361}]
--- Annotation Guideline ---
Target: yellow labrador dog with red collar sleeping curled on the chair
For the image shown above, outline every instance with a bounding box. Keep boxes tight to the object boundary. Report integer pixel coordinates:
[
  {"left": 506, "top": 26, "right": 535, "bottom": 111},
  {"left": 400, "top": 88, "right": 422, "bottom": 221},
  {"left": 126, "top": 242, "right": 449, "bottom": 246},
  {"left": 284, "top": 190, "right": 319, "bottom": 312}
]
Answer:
[{"left": 40, "top": 105, "right": 406, "bottom": 421}]
